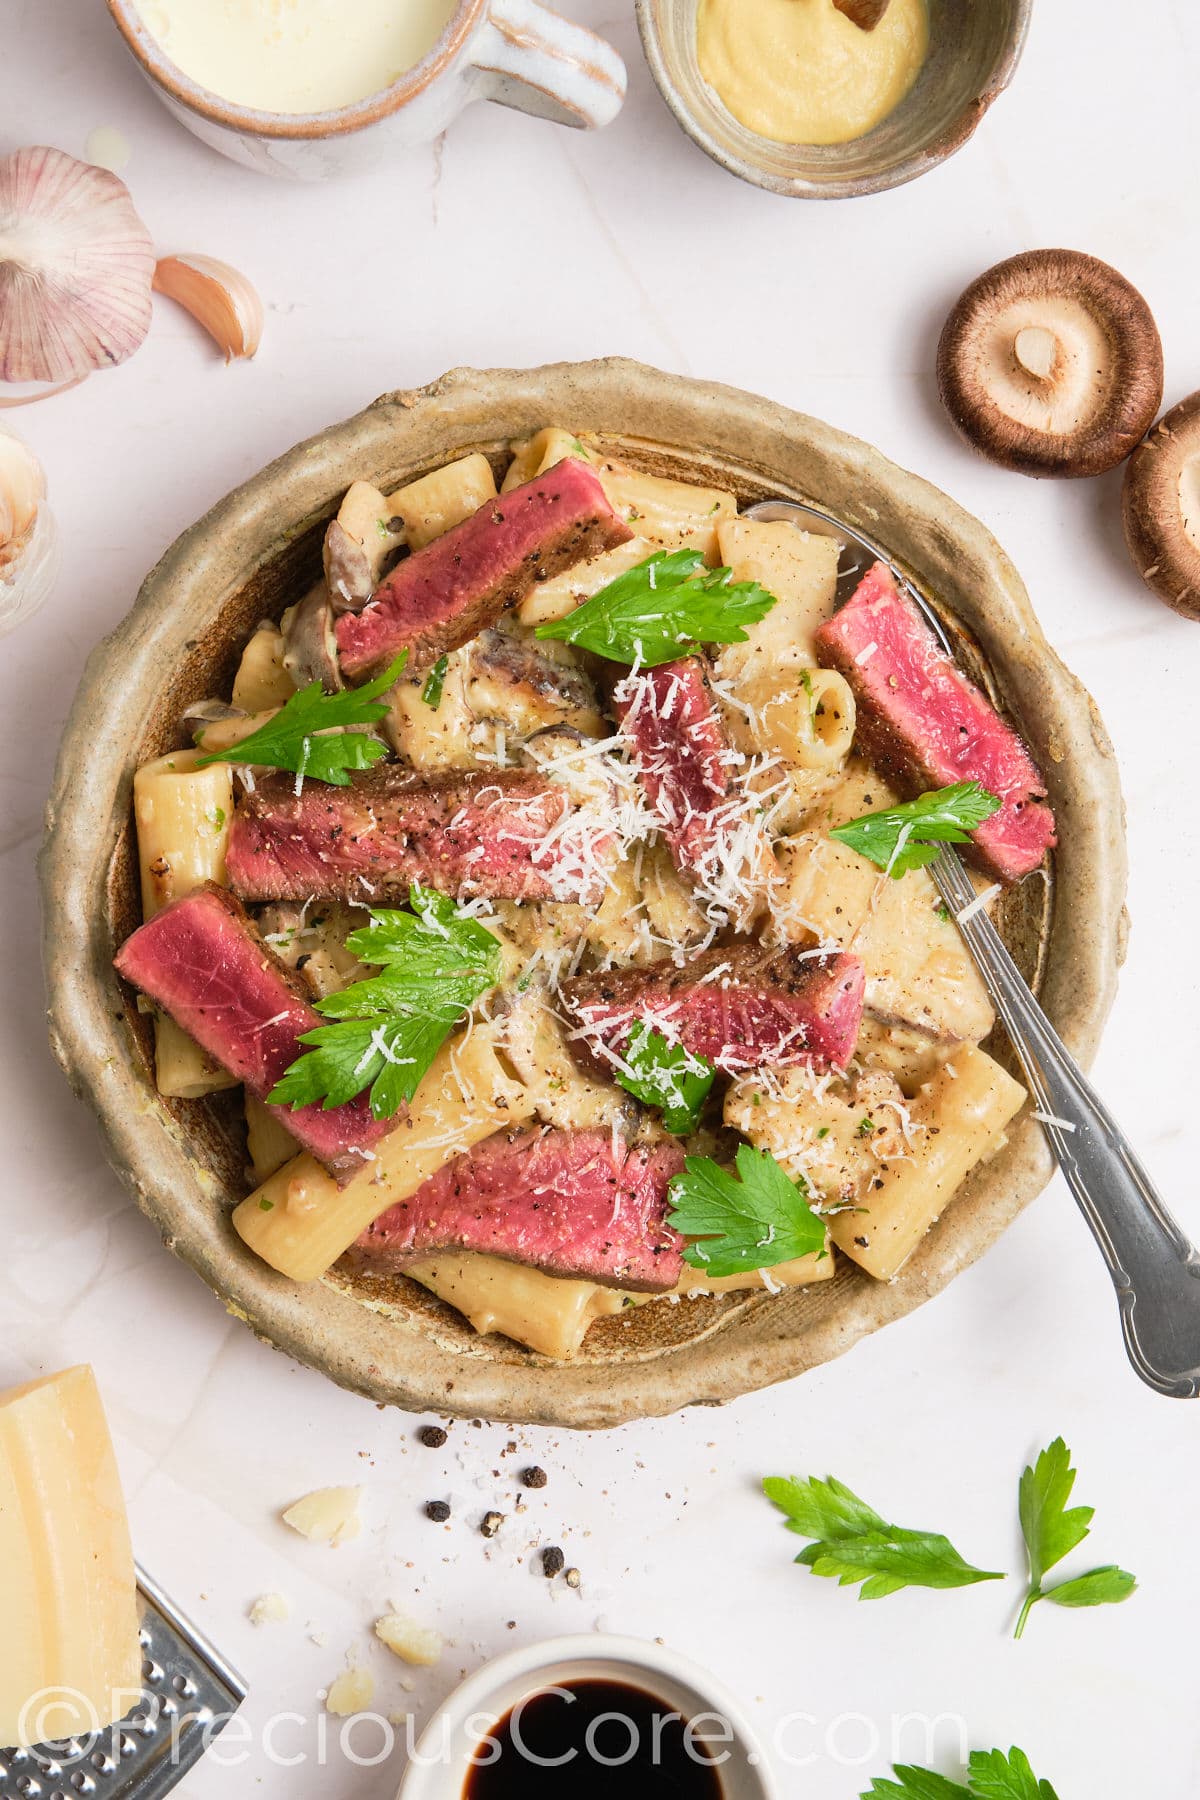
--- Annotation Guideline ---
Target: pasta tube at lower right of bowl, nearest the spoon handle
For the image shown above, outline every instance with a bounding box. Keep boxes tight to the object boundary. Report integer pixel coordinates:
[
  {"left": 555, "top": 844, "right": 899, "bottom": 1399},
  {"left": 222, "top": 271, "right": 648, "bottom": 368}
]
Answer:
[{"left": 829, "top": 1048, "right": 1025, "bottom": 1282}]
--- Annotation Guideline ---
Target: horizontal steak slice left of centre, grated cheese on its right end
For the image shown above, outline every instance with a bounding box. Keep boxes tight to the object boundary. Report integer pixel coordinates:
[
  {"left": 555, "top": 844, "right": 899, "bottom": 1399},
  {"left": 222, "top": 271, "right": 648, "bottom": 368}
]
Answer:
[{"left": 225, "top": 763, "right": 608, "bottom": 905}]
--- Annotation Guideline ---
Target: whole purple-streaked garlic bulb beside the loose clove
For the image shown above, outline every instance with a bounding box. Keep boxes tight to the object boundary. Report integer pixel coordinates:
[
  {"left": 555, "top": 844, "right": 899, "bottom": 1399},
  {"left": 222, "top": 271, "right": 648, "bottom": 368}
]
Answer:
[{"left": 0, "top": 146, "right": 155, "bottom": 382}]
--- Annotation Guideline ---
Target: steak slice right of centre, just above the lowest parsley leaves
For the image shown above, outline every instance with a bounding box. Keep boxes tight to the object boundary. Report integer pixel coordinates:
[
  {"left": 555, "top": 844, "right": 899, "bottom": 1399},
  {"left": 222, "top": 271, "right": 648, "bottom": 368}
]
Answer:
[{"left": 561, "top": 943, "right": 865, "bottom": 1073}]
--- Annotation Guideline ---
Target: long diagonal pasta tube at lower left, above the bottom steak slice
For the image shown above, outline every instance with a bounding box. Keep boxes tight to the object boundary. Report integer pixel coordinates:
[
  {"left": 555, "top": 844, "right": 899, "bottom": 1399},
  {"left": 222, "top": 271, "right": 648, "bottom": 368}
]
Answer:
[{"left": 234, "top": 1024, "right": 533, "bottom": 1282}]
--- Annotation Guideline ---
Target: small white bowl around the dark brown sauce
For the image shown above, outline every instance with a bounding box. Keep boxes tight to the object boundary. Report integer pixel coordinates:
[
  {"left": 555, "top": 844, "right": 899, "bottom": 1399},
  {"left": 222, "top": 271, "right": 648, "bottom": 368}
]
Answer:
[{"left": 396, "top": 1633, "right": 779, "bottom": 1800}]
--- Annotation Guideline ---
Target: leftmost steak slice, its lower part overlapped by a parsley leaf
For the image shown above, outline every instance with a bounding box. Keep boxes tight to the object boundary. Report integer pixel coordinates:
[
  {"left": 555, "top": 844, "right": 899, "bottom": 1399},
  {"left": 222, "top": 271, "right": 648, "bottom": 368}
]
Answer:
[{"left": 115, "top": 886, "right": 399, "bottom": 1183}]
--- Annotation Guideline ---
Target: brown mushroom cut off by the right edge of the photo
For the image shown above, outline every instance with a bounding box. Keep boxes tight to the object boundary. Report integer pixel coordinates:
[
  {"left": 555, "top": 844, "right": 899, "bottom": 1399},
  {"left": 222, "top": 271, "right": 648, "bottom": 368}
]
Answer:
[{"left": 1121, "top": 392, "right": 1200, "bottom": 619}]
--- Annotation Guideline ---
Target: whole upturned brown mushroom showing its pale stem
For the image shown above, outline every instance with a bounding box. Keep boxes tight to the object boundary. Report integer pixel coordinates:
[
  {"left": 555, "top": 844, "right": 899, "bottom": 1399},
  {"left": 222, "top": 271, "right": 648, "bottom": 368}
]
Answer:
[{"left": 937, "top": 250, "right": 1162, "bottom": 475}]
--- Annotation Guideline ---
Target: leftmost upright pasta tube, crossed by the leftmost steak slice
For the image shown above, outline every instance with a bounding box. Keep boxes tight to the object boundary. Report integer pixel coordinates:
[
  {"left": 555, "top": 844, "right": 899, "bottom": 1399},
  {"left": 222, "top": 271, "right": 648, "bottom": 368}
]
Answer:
[{"left": 133, "top": 751, "right": 237, "bottom": 1100}]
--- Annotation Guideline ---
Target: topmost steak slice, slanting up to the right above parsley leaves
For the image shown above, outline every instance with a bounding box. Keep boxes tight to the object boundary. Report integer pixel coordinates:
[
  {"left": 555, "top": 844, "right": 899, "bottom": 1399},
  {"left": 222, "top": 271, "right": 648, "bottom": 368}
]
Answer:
[{"left": 336, "top": 457, "right": 633, "bottom": 682}]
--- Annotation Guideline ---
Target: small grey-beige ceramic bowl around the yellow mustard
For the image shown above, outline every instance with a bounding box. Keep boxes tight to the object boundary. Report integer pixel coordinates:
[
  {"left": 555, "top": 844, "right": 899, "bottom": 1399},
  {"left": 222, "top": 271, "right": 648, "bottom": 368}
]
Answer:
[{"left": 637, "top": 0, "right": 1033, "bottom": 200}]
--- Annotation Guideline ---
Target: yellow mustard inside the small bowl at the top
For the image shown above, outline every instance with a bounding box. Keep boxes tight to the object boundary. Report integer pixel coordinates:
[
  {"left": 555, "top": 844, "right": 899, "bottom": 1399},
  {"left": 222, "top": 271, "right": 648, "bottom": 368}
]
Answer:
[{"left": 696, "top": 0, "right": 928, "bottom": 144}]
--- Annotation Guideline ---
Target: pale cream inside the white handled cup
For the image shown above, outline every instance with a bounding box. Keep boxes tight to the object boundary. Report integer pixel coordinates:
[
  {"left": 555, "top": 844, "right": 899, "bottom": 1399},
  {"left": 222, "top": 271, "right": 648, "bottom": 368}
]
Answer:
[{"left": 140, "top": 0, "right": 457, "bottom": 113}]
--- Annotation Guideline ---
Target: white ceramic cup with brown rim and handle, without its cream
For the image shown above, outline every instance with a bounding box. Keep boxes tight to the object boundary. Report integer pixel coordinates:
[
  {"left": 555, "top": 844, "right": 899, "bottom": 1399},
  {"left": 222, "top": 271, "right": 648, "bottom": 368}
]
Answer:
[{"left": 108, "top": 0, "right": 626, "bottom": 180}]
